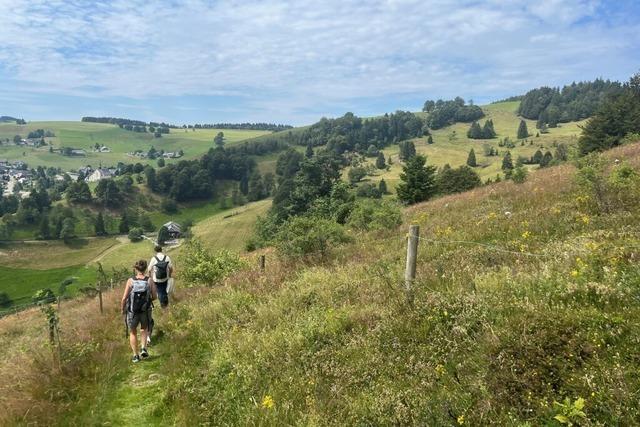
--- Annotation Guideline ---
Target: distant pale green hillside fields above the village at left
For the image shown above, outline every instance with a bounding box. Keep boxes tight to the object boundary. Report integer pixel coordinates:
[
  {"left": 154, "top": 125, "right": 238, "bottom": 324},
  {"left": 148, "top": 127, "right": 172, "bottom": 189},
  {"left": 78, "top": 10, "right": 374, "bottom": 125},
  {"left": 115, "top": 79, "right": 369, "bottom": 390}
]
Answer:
[{"left": 0, "top": 121, "right": 270, "bottom": 170}]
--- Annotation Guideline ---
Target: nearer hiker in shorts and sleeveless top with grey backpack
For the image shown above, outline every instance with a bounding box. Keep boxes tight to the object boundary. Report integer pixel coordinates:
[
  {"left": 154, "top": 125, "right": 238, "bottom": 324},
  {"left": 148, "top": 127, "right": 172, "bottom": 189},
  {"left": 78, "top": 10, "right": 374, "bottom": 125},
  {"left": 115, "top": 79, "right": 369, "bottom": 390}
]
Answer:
[{"left": 121, "top": 259, "right": 156, "bottom": 363}]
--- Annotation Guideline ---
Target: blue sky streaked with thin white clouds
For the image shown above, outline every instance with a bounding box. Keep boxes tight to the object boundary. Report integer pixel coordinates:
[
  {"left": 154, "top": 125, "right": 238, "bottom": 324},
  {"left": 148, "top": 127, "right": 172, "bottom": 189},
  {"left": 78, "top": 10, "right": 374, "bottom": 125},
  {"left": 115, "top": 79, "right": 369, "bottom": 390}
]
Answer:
[{"left": 0, "top": 0, "right": 640, "bottom": 125}]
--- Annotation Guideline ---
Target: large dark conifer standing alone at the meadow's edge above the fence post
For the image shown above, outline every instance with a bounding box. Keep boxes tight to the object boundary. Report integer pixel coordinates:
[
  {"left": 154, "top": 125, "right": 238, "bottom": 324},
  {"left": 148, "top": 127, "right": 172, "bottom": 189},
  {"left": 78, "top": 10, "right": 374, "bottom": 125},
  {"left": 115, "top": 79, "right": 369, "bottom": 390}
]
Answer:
[{"left": 396, "top": 156, "right": 436, "bottom": 204}]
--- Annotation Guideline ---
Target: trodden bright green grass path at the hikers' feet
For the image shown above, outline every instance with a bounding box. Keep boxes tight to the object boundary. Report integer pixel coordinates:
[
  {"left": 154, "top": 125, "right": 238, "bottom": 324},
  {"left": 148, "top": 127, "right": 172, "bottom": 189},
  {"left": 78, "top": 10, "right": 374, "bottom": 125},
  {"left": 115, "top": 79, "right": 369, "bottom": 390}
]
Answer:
[{"left": 96, "top": 319, "right": 173, "bottom": 426}]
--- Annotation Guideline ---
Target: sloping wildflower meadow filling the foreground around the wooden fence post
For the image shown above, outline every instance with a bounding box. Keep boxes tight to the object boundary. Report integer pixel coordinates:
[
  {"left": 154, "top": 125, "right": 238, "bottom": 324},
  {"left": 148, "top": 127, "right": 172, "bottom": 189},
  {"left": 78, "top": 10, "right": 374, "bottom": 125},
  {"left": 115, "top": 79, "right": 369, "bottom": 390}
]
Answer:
[{"left": 0, "top": 144, "right": 640, "bottom": 426}]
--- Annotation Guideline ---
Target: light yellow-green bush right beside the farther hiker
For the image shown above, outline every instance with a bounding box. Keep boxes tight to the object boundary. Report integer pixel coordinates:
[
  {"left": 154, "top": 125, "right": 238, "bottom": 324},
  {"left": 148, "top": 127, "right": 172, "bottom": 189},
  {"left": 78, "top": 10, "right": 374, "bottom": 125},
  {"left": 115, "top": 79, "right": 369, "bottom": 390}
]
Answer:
[{"left": 180, "top": 239, "right": 245, "bottom": 286}]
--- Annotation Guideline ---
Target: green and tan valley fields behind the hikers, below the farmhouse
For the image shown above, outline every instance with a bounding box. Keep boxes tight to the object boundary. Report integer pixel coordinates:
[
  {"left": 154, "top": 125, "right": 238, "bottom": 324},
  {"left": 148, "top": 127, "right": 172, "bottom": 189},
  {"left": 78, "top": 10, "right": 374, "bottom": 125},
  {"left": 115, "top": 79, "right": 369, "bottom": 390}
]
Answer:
[{"left": 0, "top": 200, "right": 271, "bottom": 305}]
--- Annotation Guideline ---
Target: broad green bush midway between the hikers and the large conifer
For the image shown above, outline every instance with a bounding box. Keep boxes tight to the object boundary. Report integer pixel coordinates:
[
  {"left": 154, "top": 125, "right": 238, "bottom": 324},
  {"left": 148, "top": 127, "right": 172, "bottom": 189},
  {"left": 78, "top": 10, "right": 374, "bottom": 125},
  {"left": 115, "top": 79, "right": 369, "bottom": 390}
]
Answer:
[{"left": 275, "top": 216, "right": 350, "bottom": 258}]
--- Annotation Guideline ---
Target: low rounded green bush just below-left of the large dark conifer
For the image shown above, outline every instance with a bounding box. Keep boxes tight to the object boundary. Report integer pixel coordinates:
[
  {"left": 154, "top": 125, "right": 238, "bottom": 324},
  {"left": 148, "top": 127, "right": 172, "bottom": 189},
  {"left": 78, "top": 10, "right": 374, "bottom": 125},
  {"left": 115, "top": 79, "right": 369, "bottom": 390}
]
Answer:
[{"left": 348, "top": 200, "right": 402, "bottom": 230}]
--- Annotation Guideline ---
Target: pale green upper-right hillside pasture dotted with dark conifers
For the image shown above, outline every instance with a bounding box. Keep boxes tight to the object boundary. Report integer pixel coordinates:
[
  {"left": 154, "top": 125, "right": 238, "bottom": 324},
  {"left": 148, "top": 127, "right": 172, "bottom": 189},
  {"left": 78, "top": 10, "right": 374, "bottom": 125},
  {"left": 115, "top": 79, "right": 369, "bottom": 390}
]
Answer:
[{"left": 356, "top": 101, "right": 584, "bottom": 191}]
